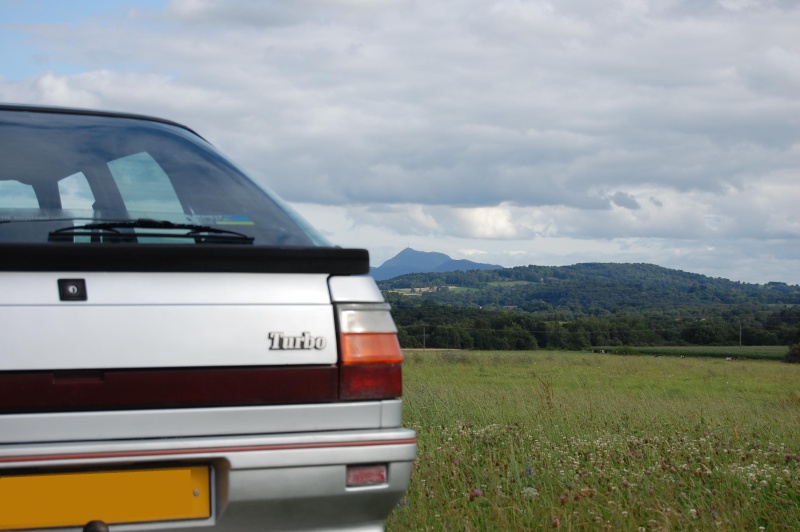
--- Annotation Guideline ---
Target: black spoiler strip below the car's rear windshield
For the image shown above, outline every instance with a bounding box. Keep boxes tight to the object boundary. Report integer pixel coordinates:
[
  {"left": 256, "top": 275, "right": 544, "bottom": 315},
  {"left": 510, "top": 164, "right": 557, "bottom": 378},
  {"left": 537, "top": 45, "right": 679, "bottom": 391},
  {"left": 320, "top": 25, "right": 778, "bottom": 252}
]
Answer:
[{"left": 0, "top": 244, "right": 369, "bottom": 275}]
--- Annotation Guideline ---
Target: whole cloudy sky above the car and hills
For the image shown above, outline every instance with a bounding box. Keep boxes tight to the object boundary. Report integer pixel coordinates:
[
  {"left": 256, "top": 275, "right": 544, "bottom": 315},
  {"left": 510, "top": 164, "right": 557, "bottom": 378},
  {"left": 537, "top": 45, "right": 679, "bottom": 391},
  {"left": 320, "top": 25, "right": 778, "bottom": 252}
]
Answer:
[{"left": 0, "top": 0, "right": 800, "bottom": 284}]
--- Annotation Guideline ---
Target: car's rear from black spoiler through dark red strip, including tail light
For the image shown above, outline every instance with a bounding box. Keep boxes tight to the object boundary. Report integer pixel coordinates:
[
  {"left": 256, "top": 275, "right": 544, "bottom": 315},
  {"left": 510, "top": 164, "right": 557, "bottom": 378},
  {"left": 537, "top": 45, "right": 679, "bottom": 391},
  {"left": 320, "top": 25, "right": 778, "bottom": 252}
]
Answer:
[{"left": 0, "top": 244, "right": 400, "bottom": 413}]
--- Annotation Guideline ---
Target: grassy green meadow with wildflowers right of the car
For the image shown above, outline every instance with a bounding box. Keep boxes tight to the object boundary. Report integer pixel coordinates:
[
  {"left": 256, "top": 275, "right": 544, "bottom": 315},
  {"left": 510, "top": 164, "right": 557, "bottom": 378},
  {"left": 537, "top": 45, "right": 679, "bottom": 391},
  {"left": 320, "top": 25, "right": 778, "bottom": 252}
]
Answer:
[{"left": 387, "top": 351, "right": 800, "bottom": 531}]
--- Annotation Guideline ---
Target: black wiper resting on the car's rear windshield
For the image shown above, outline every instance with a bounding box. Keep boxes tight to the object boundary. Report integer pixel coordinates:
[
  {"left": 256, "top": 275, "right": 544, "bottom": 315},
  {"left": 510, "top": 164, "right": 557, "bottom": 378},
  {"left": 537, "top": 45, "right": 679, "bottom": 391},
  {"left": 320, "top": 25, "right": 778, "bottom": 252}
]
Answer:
[{"left": 48, "top": 218, "right": 255, "bottom": 244}]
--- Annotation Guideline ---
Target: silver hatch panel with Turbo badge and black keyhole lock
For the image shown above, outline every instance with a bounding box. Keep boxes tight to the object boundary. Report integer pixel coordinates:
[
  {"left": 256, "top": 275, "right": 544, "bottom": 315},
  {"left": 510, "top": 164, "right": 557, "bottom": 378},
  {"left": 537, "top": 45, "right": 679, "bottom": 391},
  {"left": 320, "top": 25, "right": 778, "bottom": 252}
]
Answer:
[{"left": 0, "top": 272, "right": 337, "bottom": 371}]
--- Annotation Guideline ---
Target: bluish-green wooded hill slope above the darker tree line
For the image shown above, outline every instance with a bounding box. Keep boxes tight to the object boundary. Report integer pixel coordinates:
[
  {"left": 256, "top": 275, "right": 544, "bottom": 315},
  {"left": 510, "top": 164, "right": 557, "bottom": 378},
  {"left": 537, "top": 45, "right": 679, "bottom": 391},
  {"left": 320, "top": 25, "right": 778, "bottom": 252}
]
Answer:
[{"left": 379, "top": 263, "right": 800, "bottom": 314}]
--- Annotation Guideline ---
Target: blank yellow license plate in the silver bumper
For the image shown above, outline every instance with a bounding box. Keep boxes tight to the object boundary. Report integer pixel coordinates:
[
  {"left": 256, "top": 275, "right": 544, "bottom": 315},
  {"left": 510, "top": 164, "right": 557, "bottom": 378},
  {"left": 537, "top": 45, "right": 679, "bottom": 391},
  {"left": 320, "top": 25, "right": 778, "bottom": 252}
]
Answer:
[{"left": 0, "top": 466, "right": 211, "bottom": 530}]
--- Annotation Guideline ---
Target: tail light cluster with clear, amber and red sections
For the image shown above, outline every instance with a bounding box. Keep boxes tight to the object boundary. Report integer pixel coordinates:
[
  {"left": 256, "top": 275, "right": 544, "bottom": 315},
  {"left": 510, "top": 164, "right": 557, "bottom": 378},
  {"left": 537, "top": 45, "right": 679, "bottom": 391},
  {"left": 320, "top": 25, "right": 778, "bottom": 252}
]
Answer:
[{"left": 337, "top": 303, "right": 403, "bottom": 401}]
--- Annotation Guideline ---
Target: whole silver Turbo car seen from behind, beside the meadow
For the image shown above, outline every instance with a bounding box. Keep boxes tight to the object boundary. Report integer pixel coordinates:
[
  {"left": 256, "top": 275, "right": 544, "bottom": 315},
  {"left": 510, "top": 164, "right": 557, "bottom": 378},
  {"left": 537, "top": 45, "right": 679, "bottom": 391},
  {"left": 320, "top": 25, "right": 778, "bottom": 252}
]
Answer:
[{"left": 0, "top": 105, "right": 416, "bottom": 531}]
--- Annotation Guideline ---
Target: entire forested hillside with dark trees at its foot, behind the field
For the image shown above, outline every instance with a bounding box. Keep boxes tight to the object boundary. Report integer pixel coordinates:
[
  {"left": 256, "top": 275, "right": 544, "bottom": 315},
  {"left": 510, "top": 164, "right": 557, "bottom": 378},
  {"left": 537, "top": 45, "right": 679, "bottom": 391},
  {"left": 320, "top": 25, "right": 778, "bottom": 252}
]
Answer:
[{"left": 379, "top": 263, "right": 800, "bottom": 349}]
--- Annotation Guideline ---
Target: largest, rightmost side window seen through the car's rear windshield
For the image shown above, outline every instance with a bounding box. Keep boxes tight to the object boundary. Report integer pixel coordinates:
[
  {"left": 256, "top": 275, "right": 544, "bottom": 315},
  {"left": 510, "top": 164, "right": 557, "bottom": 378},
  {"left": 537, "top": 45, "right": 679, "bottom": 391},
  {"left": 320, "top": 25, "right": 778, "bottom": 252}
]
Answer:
[{"left": 108, "top": 152, "right": 183, "bottom": 216}]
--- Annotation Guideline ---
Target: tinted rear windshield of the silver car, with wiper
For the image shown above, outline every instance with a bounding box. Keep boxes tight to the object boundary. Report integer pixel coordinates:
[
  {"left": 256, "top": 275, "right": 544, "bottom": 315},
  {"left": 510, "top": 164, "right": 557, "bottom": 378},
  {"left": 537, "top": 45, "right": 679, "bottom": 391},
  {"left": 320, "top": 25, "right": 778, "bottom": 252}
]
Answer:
[{"left": 0, "top": 109, "right": 330, "bottom": 247}]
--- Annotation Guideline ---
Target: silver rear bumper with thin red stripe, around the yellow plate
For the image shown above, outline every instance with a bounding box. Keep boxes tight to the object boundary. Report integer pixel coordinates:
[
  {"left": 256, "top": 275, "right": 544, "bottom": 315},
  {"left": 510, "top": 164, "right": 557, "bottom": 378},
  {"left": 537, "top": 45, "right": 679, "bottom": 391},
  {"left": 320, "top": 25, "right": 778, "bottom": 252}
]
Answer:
[{"left": 0, "top": 428, "right": 416, "bottom": 531}]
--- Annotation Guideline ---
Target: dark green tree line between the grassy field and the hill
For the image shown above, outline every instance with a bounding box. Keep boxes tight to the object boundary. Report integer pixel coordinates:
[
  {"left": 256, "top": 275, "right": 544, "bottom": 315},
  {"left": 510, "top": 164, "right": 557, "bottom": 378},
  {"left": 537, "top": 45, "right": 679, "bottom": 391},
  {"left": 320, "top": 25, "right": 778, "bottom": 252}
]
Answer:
[{"left": 387, "top": 300, "right": 800, "bottom": 350}]
